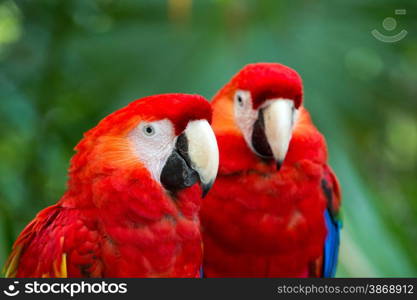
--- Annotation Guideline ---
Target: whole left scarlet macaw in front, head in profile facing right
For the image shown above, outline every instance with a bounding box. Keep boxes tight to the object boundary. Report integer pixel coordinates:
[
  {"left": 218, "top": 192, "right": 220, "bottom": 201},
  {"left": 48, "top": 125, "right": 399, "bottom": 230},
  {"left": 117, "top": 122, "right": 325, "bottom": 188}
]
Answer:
[{"left": 5, "top": 94, "right": 219, "bottom": 277}]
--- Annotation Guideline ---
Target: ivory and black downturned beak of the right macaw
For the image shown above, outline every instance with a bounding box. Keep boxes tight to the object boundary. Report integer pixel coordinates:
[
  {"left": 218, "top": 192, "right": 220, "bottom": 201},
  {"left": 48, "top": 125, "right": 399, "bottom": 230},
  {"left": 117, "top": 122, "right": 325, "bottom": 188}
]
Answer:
[{"left": 252, "top": 99, "right": 295, "bottom": 170}]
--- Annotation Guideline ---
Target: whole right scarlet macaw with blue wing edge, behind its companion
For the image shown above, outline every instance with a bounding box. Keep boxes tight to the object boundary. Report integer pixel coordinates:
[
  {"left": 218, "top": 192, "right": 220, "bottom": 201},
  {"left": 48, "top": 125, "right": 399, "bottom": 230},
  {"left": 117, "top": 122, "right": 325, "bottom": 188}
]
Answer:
[{"left": 200, "top": 63, "right": 340, "bottom": 277}]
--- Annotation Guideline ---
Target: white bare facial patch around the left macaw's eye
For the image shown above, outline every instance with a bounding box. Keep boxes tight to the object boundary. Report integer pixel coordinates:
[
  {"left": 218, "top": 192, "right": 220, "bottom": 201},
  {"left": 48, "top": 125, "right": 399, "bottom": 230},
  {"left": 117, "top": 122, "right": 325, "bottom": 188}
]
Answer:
[{"left": 128, "top": 119, "right": 176, "bottom": 183}]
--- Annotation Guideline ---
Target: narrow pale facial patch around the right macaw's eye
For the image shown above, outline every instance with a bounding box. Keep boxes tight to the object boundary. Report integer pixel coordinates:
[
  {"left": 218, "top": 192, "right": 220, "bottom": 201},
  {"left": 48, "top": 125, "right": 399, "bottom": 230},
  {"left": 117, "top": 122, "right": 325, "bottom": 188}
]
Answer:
[{"left": 234, "top": 90, "right": 258, "bottom": 150}]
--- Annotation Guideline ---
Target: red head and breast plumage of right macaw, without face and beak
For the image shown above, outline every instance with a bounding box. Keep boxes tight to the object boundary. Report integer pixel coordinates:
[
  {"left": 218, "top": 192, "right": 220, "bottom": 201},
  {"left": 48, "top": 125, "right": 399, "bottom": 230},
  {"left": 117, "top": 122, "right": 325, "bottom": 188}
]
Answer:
[{"left": 200, "top": 64, "right": 340, "bottom": 277}]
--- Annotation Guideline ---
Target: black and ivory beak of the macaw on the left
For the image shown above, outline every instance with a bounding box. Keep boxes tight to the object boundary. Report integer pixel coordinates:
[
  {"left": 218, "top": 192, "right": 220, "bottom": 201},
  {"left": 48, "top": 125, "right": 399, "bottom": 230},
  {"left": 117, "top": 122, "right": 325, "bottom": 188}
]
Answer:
[{"left": 161, "top": 120, "right": 219, "bottom": 197}]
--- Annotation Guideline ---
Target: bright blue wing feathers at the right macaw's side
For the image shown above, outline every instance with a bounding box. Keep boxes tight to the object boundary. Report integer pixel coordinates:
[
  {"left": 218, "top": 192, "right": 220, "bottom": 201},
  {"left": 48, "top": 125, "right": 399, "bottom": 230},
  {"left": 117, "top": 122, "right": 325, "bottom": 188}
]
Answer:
[{"left": 323, "top": 209, "right": 341, "bottom": 278}]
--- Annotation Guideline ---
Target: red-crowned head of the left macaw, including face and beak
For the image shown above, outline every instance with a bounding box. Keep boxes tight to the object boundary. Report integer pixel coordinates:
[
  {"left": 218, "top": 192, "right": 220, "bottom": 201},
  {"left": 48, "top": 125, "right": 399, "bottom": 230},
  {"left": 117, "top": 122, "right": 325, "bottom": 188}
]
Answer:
[{"left": 69, "top": 94, "right": 219, "bottom": 206}]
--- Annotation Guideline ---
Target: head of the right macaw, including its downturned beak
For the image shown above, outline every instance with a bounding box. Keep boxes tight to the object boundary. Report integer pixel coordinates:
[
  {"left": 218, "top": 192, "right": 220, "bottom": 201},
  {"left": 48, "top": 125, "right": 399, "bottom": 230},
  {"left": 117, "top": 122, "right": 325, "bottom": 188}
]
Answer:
[{"left": 213, "top": 63, "right": 303, "bottom": 170}]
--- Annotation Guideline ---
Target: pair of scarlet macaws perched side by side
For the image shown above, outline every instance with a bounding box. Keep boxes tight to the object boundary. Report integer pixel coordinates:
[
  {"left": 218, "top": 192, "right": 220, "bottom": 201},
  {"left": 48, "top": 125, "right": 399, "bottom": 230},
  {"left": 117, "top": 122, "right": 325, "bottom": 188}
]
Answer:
[{"left": 4, "top": 63, "right": 340, "bottom": 277}]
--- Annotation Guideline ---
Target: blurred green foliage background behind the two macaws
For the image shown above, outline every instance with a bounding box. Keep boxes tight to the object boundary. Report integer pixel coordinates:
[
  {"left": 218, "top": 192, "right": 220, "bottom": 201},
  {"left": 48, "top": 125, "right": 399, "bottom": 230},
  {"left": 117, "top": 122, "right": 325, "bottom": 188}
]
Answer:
[{"left": 0, "top": 0, "right": 417, "bottom": 277}]
